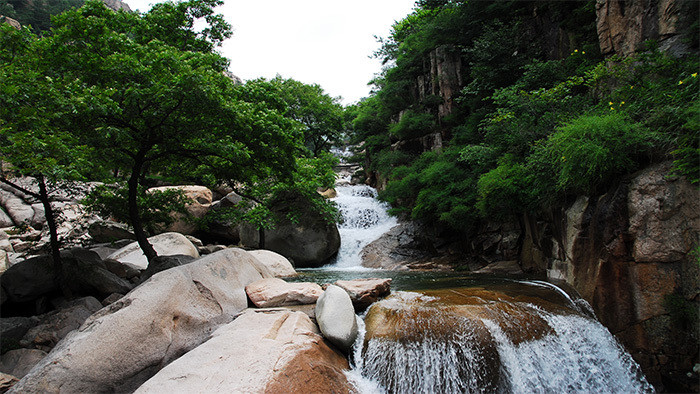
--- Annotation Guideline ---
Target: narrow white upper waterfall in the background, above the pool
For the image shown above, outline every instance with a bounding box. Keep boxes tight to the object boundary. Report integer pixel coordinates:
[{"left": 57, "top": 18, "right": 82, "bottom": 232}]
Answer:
[{"left": 323, "top": 185, "right": 397, "bottom": 270}]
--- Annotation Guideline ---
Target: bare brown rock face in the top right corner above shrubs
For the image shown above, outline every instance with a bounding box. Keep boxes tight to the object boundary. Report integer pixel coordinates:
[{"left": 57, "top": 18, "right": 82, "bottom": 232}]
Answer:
[{"left": 596, "top": 0, "right": 697, "bottom": 56}]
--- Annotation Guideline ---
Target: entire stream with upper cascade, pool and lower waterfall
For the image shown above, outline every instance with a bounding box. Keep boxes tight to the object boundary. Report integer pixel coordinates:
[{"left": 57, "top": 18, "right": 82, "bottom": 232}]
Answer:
[{"left": 295, "top": 179, "right": 654, "bottom": 393}]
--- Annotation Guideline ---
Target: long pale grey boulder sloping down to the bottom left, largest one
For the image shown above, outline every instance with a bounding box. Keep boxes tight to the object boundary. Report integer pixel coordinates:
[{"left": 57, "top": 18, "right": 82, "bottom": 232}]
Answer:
[{"left": 13, "top": 248, "right": 271, "bottom": 393}]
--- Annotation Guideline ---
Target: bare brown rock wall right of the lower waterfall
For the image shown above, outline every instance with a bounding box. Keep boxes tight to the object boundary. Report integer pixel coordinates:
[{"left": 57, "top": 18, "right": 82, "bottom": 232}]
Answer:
[{"left": 522, "top": 162, "right": 700, "bottom": 392}]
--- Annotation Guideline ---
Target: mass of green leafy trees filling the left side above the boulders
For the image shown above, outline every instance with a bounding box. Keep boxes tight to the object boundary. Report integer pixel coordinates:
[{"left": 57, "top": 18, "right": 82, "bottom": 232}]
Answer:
[{"left": 0, "top": 0, "right": 343, "bottom": 278}]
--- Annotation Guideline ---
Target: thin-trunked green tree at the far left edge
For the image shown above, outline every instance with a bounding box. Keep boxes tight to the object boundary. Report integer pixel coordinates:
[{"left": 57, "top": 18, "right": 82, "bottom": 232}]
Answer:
[{"left": 0, "top": 24, "right": 95, "bottom": 296}]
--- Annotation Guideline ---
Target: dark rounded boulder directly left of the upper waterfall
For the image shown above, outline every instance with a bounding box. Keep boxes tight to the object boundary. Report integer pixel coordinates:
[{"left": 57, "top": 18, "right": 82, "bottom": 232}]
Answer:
[{"left": 260, "top": 193, "right": 340, "bottom": 267}]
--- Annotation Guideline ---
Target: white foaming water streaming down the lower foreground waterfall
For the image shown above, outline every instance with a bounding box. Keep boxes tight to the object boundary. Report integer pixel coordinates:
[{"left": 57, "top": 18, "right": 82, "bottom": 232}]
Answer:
[{"left": 349, "top": 292, "right": 654, "bottom": 393}]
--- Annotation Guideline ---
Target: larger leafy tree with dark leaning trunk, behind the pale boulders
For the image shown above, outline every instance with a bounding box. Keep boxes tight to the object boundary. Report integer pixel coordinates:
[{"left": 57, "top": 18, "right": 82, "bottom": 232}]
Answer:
[{"left": 39, "top": 0, "right": 299, "bottom": 262}]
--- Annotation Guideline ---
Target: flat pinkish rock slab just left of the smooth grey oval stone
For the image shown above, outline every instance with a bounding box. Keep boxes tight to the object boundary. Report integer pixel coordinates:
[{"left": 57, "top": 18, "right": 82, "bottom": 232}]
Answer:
[{"left": 245, "top": 278, "right": 323, "bottom": 308}]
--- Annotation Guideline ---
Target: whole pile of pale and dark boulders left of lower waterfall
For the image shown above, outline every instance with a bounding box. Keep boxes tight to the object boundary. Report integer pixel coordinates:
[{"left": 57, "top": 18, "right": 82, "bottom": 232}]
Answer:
[{"left": 0, "top": 242, "right": 390, "bottom": 392}]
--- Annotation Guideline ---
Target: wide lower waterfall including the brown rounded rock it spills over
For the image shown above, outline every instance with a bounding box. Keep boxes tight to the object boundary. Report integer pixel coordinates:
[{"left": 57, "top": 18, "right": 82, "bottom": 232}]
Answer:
[{"left": 348, "top": 288, "right": 654, "bottom": 393}]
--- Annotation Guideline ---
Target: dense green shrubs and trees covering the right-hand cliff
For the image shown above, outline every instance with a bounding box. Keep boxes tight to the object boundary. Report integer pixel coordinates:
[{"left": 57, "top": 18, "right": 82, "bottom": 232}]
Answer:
[{"left": 353, "top": 0, "right": 700, "bottom": 231}]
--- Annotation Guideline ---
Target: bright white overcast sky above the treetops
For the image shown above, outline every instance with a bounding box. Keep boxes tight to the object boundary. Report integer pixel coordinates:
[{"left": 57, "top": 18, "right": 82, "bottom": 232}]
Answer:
[{"left": 123, "top": 0, "right": 415, "bottom": 104}]
